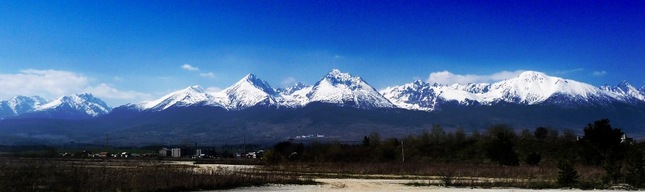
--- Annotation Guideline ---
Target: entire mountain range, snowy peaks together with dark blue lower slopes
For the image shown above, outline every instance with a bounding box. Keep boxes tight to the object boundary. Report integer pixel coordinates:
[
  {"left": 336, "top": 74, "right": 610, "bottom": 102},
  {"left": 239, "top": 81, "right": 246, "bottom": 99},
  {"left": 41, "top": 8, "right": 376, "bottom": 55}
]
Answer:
[{"left": 0, "top": 69, "right": 645, "bottom": 145}]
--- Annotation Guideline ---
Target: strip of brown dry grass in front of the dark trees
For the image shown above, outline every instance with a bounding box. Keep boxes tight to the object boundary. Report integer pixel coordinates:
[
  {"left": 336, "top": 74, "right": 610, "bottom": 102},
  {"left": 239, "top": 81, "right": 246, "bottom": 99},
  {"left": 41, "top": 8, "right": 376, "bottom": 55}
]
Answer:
[{"left": 266, "top": 163, "right": 605, "bottom": 189}]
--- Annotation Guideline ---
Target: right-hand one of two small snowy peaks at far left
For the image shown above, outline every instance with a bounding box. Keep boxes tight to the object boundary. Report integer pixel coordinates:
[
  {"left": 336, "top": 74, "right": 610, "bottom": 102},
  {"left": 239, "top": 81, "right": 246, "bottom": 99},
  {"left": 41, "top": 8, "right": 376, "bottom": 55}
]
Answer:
[{"left": 34, "top": 93, "right": 112, "bottom": 117}]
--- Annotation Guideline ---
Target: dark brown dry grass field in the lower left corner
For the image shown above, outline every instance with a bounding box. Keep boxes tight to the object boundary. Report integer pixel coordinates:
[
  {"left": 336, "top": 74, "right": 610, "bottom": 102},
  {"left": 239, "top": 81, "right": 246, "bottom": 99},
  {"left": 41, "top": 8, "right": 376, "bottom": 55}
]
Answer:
[{"left": 0, "top": 158, "right": 314, "bottom": 192}]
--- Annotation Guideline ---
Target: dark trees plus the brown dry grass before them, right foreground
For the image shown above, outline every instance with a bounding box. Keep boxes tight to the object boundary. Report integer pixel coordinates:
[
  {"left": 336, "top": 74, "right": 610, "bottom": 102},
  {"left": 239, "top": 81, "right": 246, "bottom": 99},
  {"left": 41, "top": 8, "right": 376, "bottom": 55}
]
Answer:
[{"left": 265, "top": 119, "right": 645, "bottom": 189}]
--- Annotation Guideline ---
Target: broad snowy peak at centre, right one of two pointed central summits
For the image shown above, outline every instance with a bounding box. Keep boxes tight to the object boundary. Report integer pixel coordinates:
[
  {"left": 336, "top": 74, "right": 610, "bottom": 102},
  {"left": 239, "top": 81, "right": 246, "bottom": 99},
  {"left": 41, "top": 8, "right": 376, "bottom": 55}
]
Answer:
[{"left": 307, "top": 69, "right": 394, "bottom": 108}]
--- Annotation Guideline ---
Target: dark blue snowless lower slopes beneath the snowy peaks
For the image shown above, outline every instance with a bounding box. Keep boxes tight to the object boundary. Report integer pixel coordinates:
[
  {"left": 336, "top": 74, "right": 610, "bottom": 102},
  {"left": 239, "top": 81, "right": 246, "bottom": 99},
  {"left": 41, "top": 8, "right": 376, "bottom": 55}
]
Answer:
[{"left": 0, "top": 103, "right": 645, "bottom": 145}]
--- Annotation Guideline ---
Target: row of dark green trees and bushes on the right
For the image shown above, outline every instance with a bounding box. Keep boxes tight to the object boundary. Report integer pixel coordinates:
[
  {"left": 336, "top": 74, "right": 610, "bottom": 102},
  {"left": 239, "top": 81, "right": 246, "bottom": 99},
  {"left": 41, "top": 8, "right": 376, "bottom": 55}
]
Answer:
[{"left": 267, "top": 119, "right": 645, "bottom": 188}]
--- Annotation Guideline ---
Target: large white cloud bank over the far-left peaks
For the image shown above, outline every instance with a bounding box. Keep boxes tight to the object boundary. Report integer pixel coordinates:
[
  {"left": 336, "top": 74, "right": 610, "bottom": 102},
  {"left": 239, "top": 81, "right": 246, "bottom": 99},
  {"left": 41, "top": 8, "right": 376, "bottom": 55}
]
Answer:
[{"left": 0, "top": 69, "right": 150, "bottom": 105}]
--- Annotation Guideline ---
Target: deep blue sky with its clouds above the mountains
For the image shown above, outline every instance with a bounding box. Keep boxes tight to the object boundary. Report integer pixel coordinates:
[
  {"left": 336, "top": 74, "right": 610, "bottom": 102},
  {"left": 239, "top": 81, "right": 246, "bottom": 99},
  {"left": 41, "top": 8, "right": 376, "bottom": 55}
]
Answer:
[{"left": 0, "top": 0, "right": 645, "bottom": 106}]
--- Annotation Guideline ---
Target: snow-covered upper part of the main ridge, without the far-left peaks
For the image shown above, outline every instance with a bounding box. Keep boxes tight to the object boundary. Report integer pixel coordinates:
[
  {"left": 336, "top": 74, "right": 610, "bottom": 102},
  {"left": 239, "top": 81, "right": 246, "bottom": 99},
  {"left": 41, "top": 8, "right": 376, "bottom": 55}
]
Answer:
[{"left": 118, "top": 70, "right": 645, "bottom": 111}]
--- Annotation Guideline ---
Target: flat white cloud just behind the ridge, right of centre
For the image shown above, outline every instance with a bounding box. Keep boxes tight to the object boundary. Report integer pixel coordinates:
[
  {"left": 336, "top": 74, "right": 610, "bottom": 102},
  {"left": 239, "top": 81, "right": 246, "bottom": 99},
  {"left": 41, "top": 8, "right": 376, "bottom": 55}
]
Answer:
[{"left": 427, "top": 70, "right": 524, "bottom": 85}]
